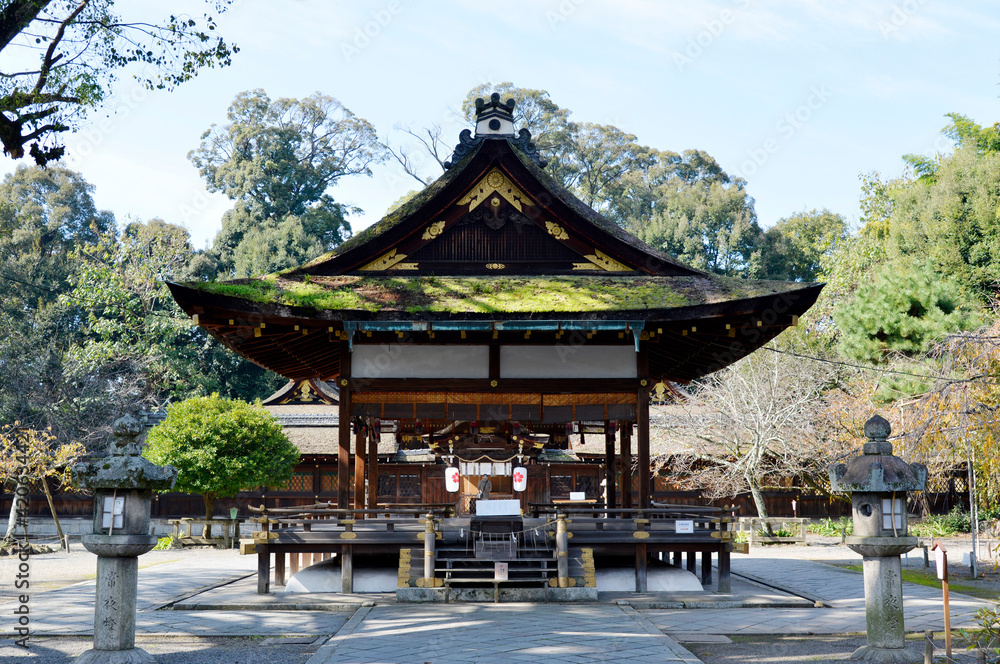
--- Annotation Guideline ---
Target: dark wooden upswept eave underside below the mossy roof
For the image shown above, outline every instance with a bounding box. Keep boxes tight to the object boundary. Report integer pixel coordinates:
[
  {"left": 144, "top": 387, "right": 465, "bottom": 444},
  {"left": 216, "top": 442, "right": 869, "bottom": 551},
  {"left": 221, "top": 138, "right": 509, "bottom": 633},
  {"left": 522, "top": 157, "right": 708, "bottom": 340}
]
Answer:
[{"left": 170, "top": 284, "right": 822, "bottom": 384}]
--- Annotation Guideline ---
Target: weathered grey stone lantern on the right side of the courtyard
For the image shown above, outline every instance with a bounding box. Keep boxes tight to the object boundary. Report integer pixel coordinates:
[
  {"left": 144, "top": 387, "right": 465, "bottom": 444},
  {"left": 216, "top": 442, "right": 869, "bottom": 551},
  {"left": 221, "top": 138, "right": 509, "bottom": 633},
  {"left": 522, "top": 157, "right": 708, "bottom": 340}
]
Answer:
[{"left": 830, "top": 415, "right": 927, "bottom": 664}]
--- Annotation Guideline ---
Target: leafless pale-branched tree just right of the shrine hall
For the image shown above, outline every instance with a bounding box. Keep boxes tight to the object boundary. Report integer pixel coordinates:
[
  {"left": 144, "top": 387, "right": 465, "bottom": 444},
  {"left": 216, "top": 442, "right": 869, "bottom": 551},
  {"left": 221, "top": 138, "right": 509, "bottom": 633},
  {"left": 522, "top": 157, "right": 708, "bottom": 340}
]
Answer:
[{"left": 673, "top": 349, "right": 829, "bottom": 517}]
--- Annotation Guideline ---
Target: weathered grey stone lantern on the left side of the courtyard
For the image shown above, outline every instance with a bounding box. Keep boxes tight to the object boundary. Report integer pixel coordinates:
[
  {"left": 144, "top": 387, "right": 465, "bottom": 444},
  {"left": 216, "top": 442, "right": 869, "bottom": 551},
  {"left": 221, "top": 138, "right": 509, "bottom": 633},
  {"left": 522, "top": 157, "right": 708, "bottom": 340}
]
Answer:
[{"left": 73, "top": 415, "right": 177, "bottom": 664}]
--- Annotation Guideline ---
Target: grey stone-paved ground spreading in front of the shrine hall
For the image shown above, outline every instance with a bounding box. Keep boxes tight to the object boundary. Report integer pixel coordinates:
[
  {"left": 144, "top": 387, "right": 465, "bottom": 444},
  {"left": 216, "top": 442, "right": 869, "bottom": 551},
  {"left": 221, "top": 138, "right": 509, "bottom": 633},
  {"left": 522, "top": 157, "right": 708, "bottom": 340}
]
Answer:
[{"left": 0, "top": 547, "right": 990, "bottom": 664}]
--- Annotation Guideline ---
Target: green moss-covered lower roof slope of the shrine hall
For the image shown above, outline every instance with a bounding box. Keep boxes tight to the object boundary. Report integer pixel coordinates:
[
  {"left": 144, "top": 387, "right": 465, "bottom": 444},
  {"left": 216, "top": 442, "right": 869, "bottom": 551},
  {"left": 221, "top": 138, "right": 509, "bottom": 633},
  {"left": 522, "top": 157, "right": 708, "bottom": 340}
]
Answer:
[{"left": 184, "top": 275, "right": 811, "bottom": 316}]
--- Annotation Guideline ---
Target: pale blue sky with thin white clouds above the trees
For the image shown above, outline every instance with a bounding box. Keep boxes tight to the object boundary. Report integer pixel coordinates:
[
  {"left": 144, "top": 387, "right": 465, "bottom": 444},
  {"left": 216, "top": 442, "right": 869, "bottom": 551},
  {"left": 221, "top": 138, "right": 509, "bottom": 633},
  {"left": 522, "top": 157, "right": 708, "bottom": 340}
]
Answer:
[{"left": 3, "top": 0, "right": 1000, "bottom": 247}]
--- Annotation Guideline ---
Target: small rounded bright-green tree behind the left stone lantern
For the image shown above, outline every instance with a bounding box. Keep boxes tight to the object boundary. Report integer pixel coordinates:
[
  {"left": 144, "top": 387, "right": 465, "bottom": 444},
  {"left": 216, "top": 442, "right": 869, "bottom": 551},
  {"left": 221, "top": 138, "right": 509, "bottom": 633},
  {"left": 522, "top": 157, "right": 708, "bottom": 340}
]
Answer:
[{"left": 143, "top": 394, "right": 299, "bottom": 537}]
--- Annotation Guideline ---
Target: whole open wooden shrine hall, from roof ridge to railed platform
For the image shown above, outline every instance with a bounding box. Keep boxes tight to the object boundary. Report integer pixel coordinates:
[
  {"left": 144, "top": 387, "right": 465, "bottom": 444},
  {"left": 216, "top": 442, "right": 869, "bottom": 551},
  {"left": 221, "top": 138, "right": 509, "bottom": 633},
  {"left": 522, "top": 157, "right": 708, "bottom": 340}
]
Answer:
[{"left": 170, "top": 95, "right": 822, "bottom": 597}]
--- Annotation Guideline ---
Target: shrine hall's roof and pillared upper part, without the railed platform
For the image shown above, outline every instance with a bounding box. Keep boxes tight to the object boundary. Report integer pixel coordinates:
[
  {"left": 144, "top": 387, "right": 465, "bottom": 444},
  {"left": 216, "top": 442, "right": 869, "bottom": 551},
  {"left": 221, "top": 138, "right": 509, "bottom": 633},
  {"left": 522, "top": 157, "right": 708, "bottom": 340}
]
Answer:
[{"left": 170, "top": 95, "right": 822, "bottom": 592}]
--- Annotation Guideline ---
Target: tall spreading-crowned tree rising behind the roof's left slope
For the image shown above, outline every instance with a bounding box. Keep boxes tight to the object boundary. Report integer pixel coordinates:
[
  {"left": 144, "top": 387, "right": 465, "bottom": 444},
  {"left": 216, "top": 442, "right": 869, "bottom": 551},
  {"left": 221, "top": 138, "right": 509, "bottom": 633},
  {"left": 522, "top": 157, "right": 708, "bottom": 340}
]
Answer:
[{"left": 188, "top": 90, "right": 385, "bottom": 277}]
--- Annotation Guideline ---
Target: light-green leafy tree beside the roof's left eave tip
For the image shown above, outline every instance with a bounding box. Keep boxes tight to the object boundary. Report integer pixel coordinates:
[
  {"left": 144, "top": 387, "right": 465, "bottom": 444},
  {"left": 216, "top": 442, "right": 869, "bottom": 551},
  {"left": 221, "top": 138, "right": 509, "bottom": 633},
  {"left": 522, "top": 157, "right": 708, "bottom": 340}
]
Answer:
[{"left": 69, "top": 219, "right": 281, "bottom": 405}]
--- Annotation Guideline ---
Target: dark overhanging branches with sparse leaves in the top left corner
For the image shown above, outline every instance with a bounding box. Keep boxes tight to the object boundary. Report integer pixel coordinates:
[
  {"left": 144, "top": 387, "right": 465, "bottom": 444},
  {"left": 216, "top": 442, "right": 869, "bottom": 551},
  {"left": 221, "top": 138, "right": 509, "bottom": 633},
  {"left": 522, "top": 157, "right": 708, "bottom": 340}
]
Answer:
[{"left": 0, "top": 0, "right": 238, "bottom": 166}]
